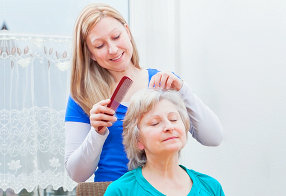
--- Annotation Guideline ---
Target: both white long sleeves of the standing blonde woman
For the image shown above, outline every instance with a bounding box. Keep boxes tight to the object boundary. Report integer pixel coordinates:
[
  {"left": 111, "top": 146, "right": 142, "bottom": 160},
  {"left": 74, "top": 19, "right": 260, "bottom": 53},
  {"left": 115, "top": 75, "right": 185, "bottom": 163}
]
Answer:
[{"left": 65, "top": 82, "right": 223, "bottom": 182}]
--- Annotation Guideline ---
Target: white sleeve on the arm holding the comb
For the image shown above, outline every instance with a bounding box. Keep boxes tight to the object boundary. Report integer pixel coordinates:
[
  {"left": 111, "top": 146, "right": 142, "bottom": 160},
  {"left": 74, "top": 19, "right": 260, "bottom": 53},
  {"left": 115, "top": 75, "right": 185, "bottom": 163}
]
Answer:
[{"left": 65, "top": 122, "right": 109, "bottom": 182}]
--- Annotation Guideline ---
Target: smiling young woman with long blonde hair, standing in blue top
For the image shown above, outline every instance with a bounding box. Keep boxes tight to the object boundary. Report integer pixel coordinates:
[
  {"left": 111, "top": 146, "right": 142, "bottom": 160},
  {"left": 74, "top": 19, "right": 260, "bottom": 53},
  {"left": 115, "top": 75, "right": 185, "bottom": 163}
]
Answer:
[{"left": 65, "top": 4, "right": 222, "bottom": 182}]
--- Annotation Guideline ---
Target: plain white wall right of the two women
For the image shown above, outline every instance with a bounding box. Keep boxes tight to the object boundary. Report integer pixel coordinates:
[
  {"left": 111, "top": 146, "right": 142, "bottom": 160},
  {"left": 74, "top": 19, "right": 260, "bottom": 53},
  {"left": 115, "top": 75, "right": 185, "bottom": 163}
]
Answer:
[{"left": 130, "top": 0, "right": 286, "bottom": 196}]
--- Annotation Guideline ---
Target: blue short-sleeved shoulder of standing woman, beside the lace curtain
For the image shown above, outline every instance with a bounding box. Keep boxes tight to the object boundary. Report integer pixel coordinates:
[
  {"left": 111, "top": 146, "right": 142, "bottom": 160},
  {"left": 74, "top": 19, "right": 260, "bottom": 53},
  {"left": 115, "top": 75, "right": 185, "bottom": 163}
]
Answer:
[{"left": 65, "top": 96, "right": 90, "bottom": 123}]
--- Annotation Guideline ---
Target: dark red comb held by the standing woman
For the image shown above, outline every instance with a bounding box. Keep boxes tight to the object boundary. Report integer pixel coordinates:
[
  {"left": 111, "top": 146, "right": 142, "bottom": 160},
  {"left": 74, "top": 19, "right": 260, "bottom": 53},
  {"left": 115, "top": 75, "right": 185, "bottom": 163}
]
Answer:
[{"left": 98, "top": 76, "right": 133, "bottom": 130}]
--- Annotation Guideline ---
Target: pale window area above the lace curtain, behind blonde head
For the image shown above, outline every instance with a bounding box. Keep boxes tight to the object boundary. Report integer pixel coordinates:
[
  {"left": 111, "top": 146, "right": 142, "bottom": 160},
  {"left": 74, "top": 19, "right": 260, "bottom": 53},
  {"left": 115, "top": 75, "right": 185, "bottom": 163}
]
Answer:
[{"left": 0, "top": 0, "right": 129, "bottom": 36}]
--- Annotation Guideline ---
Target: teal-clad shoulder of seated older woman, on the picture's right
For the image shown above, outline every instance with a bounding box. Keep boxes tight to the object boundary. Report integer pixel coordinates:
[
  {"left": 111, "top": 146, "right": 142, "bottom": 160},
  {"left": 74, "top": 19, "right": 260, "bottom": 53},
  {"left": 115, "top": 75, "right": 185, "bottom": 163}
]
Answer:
[{"left": 188, "top": 170, "right": 224, "bottom": 195}]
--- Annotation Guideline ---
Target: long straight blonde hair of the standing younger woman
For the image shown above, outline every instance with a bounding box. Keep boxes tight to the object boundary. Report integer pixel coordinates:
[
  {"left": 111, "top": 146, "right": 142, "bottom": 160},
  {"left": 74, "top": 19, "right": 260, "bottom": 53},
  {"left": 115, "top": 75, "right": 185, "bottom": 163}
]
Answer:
[{"left": 70, "top": 3, "right": 140, "bottom": 115}]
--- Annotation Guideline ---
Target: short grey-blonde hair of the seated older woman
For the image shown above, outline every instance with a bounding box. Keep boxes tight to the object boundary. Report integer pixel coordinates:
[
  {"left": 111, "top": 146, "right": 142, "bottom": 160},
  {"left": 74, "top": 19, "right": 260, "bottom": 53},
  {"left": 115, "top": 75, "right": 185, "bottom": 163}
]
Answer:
[{"left": 123, "top": 89, "right": 190, "bottom": 170}]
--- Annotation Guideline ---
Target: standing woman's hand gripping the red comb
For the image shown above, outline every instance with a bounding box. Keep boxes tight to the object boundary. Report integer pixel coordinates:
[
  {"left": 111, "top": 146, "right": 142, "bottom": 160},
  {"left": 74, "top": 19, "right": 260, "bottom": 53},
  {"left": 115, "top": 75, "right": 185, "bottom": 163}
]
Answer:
[{"left": 90, "top": 99, "right": 117, "bottom": 135}]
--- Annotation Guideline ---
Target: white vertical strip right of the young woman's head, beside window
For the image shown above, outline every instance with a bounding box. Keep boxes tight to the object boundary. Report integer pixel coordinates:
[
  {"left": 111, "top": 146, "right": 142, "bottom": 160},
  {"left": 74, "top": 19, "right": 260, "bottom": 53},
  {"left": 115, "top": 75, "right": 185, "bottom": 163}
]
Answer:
[{"left": 129, "top": 0, "right": 177, "bottom": 70}]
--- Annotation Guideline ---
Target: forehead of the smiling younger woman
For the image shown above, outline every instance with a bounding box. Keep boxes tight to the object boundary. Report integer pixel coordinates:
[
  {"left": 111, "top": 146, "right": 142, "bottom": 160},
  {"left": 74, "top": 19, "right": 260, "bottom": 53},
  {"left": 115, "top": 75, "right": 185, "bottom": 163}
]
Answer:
[{"left": 88, "top": 16, "right": 124, "bottom": 39}]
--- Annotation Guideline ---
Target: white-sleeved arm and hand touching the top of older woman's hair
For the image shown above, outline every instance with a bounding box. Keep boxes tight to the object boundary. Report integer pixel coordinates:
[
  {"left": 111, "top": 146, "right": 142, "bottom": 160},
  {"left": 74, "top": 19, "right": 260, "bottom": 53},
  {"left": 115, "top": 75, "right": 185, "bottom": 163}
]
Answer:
[{"left": 149, "top": 72, "right": 225, "bottom": 146}]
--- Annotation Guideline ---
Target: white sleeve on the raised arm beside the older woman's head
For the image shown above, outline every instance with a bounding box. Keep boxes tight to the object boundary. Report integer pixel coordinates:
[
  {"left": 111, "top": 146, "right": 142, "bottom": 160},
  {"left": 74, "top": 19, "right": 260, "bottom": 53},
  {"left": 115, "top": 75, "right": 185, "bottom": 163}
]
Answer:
[{"left": 179, "top": 82, "right": 223, "bottom": 146}]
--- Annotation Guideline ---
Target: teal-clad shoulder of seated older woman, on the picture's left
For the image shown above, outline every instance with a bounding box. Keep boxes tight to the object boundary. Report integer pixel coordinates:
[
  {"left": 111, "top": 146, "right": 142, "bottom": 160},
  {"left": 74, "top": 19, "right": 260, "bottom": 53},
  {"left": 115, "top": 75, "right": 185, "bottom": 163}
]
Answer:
[{"left": 104, "top": 169, "right": 137, "bottom": 195}]
